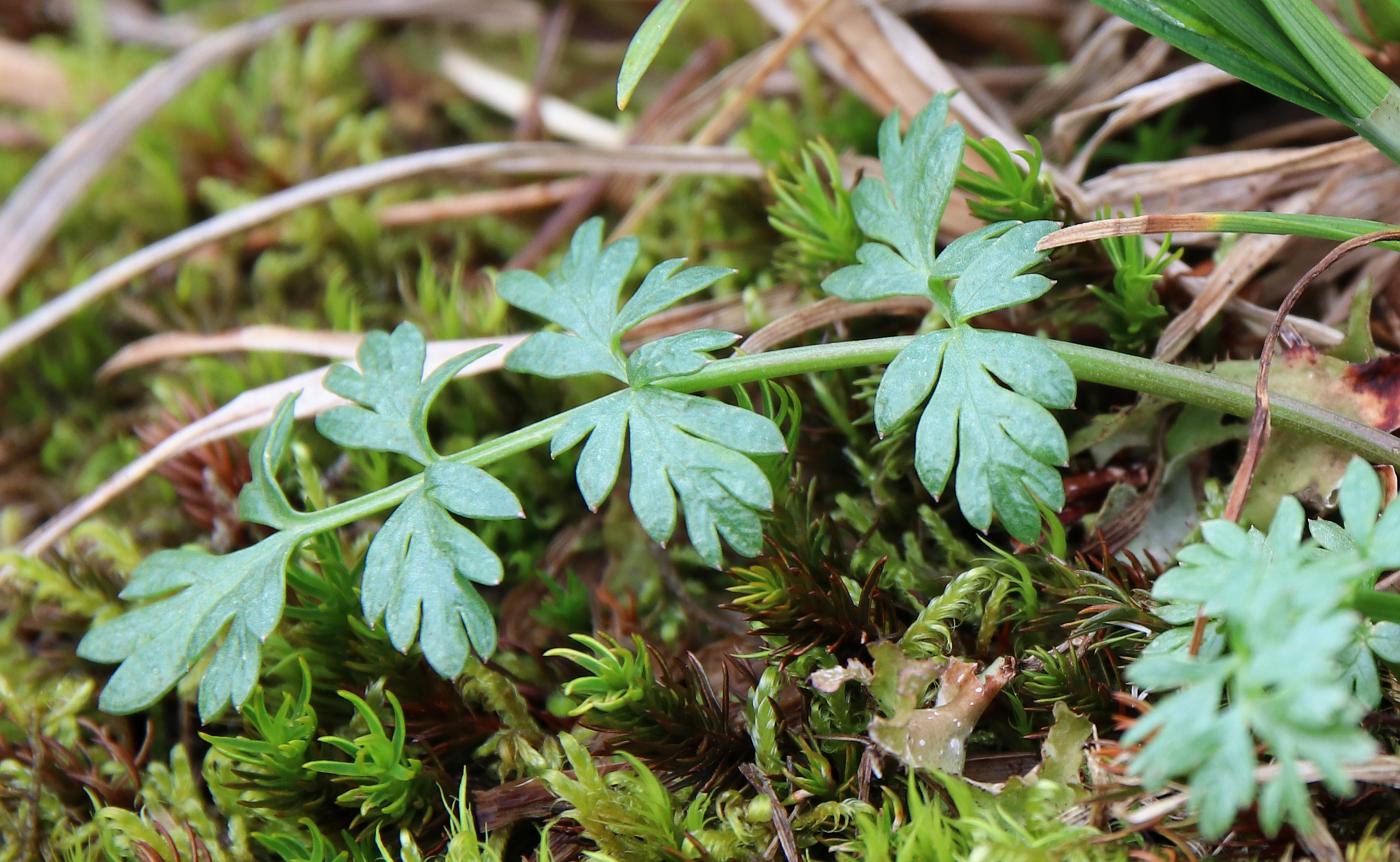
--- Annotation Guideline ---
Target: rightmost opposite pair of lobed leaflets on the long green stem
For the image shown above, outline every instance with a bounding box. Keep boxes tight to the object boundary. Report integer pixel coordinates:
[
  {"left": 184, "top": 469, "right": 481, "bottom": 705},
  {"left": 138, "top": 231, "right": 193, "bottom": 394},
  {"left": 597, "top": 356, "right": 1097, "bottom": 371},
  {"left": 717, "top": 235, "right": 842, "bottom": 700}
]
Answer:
[{"left": 822, "top": 97, "right": 1058, "bottom": 543}]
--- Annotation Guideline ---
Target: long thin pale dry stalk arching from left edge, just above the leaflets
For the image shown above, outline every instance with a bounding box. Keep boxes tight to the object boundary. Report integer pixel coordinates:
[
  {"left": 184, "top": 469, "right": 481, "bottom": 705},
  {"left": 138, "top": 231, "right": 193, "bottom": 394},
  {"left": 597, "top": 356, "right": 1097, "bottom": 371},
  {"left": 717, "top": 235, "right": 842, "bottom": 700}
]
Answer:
[{"left": 0, "top": 143, "right": 762, "bottom": 362}]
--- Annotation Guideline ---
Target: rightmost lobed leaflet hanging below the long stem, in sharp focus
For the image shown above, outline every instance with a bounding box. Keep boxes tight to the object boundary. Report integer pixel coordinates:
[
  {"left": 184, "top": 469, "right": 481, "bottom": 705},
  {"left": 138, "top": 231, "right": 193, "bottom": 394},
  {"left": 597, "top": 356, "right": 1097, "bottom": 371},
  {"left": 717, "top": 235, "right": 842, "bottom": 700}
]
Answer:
[{"left": 875, "top": 326, "right": 1074, "bottom": 543}]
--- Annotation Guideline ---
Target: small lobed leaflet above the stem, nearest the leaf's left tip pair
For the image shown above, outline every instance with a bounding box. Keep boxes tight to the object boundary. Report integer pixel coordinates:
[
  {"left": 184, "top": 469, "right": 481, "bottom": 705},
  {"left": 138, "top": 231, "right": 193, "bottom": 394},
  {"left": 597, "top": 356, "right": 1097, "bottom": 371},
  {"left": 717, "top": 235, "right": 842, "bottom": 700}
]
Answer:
[{"left": 316, "top": 323, "right": 496, "bottom": 465}]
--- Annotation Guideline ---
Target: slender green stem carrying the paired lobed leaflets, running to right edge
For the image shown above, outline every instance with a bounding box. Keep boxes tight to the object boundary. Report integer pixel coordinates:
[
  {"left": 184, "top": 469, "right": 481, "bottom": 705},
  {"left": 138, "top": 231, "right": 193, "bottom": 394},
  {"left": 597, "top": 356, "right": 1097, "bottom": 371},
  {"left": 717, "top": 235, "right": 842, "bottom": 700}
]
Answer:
[{"left": 275, "top": 336, "right": 1400, "bottom": 536}]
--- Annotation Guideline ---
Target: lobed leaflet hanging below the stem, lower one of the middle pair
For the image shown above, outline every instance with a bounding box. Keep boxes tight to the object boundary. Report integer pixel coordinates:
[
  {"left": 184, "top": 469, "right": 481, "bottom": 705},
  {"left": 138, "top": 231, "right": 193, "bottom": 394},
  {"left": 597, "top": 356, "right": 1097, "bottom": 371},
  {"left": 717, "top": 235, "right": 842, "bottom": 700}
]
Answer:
[{"left": 550, "top": 386, "right": 785, "bottom": 567}]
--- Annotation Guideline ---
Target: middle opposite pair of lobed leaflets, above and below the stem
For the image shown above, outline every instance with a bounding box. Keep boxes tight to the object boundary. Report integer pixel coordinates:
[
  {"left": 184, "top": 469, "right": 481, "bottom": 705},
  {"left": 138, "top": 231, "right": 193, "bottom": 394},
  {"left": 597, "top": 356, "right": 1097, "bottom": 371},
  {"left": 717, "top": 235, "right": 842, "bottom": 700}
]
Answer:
[{"left": 497, "top": 218, "right": 785, "bottom": 565}]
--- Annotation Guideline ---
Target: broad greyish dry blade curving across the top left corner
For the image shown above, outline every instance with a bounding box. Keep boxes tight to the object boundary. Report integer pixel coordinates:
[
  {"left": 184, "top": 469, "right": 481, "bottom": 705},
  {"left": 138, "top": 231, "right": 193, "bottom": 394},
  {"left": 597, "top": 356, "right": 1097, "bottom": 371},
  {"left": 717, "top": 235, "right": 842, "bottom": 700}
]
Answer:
[{"left": 0, "top": 0, "right": 534, "bottom": 297}]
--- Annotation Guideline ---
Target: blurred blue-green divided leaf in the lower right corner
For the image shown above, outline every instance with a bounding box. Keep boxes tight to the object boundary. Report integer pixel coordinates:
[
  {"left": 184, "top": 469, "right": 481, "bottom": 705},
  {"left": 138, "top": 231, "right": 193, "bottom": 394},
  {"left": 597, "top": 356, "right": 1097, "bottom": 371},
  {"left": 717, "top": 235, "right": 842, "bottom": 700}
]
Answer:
[{"left": 1124, "top": 460, "right": 1400, "bottom": 835}]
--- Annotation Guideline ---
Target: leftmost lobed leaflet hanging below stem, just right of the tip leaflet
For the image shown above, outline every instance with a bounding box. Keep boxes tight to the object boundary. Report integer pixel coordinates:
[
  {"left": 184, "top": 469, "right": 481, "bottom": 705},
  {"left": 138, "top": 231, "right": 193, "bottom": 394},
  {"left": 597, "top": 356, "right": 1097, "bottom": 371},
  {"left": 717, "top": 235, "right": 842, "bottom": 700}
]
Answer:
[{"left": 360, "top": 460, "right": 525, "bottom": 677}]
